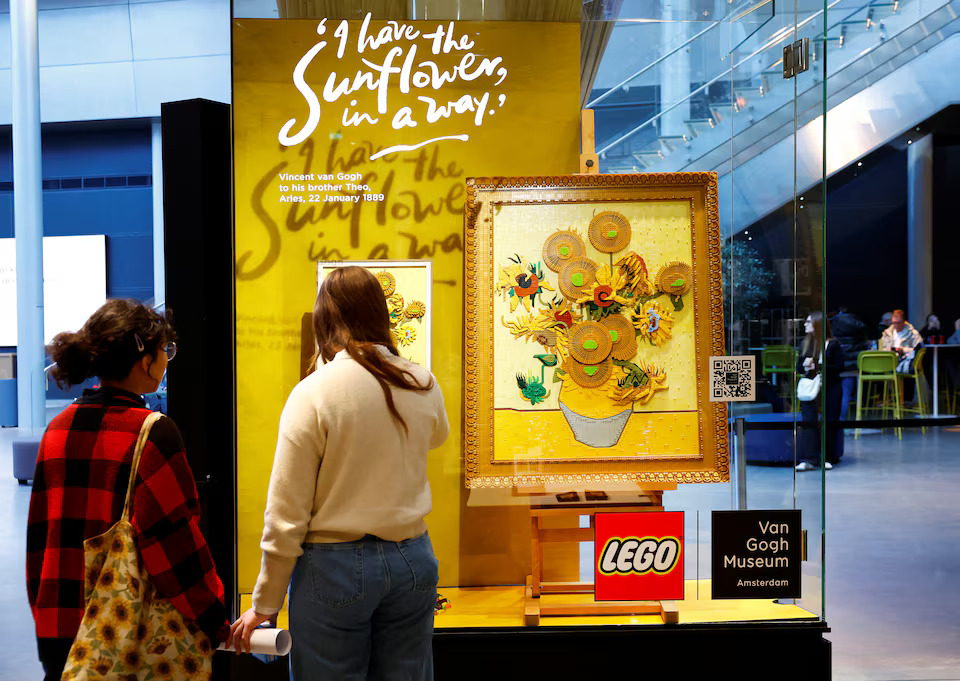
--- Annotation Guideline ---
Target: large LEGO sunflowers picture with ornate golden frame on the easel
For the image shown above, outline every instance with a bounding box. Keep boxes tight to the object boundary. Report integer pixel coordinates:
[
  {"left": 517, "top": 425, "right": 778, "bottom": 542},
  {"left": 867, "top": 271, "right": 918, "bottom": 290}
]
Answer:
[{"left": 464, "top": 173, "right": 729, "bottom": 488}]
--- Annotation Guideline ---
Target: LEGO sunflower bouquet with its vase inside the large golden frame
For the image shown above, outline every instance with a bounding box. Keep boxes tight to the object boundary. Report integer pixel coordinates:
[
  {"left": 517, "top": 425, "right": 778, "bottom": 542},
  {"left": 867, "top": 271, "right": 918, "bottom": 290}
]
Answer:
[{"left": 494, "top": 210, "right": 693, "bottom": 448}]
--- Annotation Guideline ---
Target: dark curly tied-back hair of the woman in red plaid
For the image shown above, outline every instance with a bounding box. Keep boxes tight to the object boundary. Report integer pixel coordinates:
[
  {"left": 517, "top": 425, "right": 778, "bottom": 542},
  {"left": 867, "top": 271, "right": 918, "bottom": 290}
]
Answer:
[{"left": 47, "top": 298, "right": 176, "bottom": 387}]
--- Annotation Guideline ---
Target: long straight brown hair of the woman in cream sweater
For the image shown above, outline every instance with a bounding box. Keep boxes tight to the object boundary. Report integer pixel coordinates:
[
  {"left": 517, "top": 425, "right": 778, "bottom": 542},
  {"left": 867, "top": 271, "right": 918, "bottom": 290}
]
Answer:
[{"left": 313, "top": 267, "right": 433, "bottom": 431}]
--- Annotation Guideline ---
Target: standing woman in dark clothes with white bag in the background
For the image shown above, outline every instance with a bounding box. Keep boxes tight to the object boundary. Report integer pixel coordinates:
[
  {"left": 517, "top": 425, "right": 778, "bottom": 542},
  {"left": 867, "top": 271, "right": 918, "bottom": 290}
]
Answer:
[{"left": 796, "top": 310, "right": 844, "bottom": 471}]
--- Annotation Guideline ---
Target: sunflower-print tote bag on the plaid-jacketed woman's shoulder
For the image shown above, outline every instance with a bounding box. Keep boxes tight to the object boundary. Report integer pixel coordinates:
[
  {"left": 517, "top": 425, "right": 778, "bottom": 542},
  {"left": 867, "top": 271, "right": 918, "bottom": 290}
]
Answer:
[{"left": 61, "top": 412, "right": 213, "bottom": 681}]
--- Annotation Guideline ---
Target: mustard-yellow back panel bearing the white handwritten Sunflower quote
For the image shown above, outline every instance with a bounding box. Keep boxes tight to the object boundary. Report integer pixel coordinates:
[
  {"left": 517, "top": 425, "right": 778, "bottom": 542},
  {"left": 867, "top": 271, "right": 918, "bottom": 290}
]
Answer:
[{"left": 233, "top": 20, "right": 579, "bottom": 593}]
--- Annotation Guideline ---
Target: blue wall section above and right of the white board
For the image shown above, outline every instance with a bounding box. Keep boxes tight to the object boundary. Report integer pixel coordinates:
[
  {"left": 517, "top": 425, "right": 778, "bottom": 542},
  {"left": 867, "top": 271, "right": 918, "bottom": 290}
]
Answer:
[{"left": 0, "top": 121, "right": 153, "bottom": 300}]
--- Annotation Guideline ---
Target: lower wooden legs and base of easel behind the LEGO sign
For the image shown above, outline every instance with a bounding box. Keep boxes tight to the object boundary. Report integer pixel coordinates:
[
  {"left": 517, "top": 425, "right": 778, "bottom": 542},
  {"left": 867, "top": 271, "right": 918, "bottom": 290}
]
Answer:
[{"left": 523, "top": 490, "right": 679, "bottom": 627}]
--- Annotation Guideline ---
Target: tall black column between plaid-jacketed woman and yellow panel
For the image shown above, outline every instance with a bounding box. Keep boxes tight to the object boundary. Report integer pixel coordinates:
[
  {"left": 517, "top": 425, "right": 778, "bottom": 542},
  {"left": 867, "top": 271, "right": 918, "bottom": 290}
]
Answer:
[{"left": 161, "top": 99, "right": 236, "bottom": 679}]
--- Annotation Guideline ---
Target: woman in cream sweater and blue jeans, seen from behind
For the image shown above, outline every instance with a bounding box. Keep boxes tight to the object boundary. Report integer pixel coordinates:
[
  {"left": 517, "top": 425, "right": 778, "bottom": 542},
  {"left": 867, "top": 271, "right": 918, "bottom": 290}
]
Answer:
[{"left": 231, "top": 267, "right": 449, "bottom": 681}]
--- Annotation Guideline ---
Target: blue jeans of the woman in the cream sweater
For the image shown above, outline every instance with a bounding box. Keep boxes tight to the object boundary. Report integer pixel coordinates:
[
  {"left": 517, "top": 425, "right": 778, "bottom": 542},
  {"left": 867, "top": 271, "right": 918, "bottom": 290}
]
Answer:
[{"left": 290, "top": 533, "right": 438, "bottom": 681}]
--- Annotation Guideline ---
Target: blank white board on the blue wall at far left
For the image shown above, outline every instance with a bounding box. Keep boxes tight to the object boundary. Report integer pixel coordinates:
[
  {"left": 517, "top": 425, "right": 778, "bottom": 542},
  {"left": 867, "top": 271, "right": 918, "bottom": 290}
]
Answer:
[{"left": 0, "top": 234, "right": 107, "bottom": 346}]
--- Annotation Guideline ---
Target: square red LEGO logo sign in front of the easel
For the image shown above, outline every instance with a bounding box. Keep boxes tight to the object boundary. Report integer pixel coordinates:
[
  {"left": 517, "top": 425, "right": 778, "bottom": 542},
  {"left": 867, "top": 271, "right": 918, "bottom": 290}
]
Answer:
[{"left": 594, "top": 511, "right": 683, "bottom": 601}]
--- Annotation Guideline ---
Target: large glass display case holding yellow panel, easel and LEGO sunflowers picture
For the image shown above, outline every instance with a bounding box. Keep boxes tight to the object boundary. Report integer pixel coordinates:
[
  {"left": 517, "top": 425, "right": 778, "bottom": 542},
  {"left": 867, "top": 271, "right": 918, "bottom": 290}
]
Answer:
[{"left": 233, "top": 0, "right": 828, "bottom": 678}]
